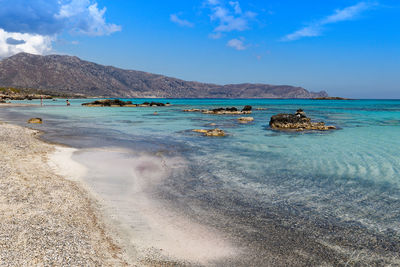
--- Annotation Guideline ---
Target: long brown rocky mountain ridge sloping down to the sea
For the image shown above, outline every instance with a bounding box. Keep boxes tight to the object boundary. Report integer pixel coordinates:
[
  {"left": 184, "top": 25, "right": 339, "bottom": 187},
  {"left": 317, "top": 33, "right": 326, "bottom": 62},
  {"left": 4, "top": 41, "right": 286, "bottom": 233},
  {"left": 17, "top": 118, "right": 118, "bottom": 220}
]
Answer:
[{"left": 0, "top": 53, "right": 328, "bottom": 98}]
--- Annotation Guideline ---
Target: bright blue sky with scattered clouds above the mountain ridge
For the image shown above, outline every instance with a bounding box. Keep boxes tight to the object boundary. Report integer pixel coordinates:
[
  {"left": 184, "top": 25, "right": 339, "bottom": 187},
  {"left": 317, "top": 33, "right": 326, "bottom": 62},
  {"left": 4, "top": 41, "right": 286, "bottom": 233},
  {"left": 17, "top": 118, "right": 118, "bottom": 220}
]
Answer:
[{"left": 0, "top": 0, "right": 400, "bottom": 99}]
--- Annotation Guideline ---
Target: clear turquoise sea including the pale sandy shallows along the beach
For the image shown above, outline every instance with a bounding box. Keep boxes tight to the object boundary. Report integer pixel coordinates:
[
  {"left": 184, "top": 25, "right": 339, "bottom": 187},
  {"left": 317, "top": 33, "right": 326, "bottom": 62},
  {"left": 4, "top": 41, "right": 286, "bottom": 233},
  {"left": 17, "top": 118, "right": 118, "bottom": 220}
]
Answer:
[{"left": 0, "top": 99, "right": 400, "bottom": 266}]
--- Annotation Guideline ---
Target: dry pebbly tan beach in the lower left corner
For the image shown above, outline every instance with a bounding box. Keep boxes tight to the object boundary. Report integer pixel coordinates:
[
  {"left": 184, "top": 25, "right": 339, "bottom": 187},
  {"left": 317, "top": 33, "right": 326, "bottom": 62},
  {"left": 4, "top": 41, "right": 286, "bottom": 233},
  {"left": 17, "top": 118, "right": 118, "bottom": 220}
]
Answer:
[{"left": 0, "top": 123, "right": 132, "bottom": 266}]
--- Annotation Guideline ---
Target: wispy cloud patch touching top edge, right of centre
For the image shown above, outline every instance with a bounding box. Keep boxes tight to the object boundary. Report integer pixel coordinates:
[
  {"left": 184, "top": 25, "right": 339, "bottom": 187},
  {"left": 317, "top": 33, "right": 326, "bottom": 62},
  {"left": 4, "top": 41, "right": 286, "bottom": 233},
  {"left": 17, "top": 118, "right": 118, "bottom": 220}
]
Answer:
[{"left": 207, "top": 0, "right": 257, "bottom": 37}]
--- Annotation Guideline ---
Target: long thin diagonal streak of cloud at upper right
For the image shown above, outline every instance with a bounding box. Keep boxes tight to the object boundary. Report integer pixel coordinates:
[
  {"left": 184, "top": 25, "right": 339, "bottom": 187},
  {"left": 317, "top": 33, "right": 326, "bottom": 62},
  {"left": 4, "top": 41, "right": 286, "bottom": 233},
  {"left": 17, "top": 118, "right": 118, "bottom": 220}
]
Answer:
[{"left": 282, "top": 2, "right": 377, "bottom": 41}]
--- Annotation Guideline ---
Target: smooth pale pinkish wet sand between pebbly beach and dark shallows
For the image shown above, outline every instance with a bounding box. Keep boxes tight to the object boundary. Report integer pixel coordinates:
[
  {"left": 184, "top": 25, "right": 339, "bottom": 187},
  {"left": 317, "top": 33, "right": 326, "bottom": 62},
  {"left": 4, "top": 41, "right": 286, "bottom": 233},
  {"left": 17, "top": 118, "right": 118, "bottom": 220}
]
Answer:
[{"left": 66, "top": 148, "right": 241, "bottom": 266}]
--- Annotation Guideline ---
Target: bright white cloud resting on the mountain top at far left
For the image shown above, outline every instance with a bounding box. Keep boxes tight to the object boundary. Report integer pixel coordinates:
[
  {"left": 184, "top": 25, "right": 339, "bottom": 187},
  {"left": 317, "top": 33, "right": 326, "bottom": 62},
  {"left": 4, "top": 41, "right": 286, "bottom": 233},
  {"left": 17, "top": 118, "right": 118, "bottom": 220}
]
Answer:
[{"left": 0, "top": 29, "right": 53, "bottom": 58}]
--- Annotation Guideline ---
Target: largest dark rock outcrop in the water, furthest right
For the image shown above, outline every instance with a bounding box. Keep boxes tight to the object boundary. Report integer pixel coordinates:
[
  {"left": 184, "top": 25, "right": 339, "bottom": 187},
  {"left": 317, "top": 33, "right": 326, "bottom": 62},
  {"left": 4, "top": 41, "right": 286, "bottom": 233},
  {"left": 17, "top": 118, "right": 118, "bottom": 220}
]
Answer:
[{"left": 269, "top": 109, "right": 336, "bottom": 131}]
